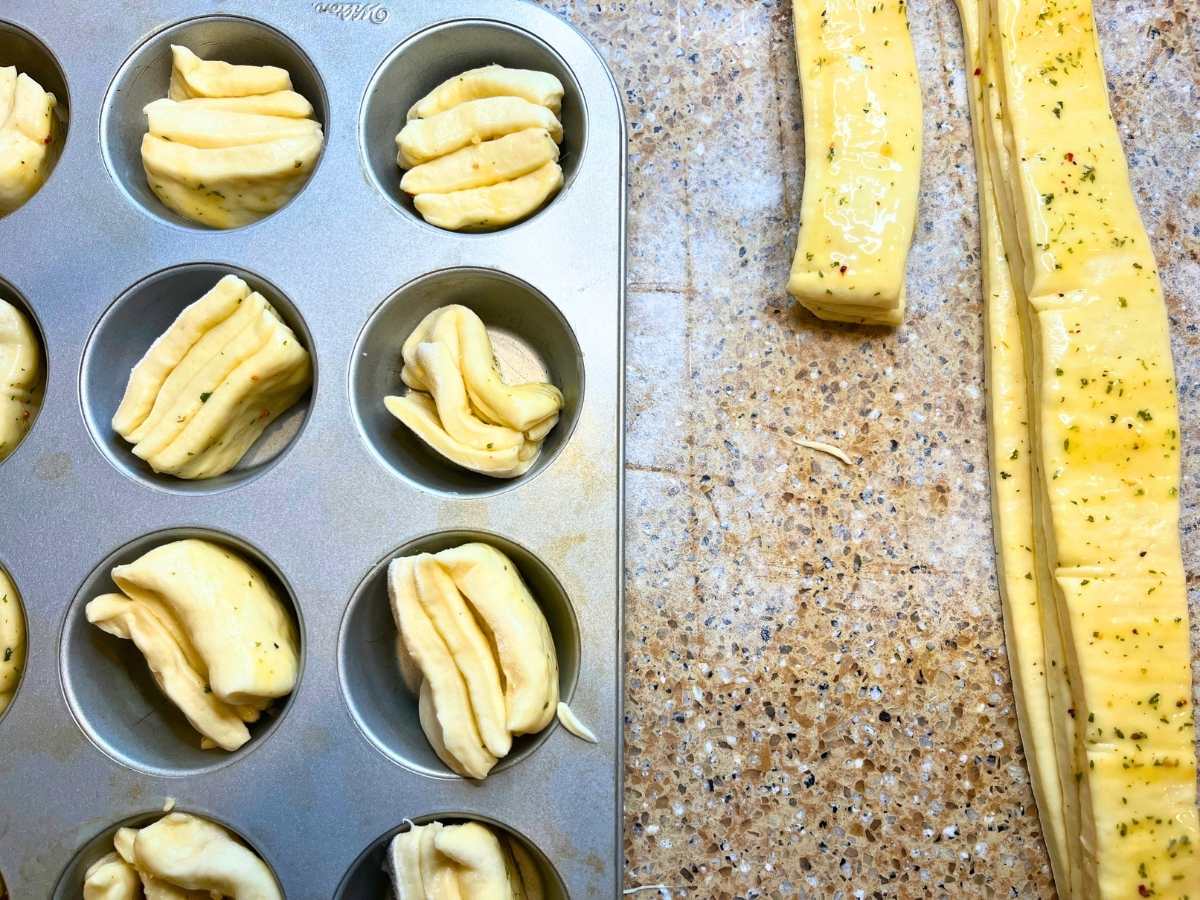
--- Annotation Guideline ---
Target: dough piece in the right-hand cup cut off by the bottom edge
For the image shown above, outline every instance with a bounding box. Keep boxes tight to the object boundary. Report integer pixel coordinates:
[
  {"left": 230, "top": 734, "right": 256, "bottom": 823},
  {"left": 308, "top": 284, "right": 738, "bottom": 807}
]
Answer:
[{"left": 385, "top": 822, "right": 545, "bottom": 900}]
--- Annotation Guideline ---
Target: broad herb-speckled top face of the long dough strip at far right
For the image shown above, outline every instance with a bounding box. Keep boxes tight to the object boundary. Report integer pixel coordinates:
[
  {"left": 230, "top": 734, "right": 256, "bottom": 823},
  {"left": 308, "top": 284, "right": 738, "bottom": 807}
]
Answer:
[{"left": 990, "top": 0, "right": 1200, "bottom": 898}]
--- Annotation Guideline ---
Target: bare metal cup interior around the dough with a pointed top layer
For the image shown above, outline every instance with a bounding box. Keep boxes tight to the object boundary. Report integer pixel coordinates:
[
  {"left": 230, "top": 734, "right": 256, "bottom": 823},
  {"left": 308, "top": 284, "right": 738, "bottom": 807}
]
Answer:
[{"left": 100, "top": 16, "right": 329, "bottom": 232}]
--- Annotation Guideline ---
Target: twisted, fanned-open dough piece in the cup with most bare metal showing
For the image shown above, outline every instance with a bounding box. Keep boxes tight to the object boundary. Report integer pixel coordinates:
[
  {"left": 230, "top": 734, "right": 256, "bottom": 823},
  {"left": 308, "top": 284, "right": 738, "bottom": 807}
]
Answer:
[{"left": 384, "top": 305, "right": 563, "bottom": 478}]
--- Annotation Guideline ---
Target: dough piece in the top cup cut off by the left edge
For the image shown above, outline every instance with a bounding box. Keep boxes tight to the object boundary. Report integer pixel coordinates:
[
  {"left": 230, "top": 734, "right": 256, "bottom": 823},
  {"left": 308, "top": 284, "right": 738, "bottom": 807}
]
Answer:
[{"left": 0, "top": 66, "right": 59, "bottom": 216}]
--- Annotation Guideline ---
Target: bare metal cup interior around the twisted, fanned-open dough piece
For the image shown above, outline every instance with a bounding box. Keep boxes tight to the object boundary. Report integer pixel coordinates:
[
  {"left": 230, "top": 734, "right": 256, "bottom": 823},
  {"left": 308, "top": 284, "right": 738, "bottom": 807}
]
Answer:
[{"left": 350, "top": 269, "right": 583, "bottom": 497}]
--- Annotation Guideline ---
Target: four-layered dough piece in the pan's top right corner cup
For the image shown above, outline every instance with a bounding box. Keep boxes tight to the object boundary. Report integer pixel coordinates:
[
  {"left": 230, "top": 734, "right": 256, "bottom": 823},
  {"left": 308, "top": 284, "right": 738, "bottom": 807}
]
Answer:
[{"left": 396, "top": 65, "right": 563, "bottom": 232}]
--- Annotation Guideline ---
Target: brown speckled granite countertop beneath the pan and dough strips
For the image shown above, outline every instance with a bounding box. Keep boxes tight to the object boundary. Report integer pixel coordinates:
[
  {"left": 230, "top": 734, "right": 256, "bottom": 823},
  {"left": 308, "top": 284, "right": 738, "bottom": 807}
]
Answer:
[{"left": 544, "top": 0, "right": 1200, "bottom": 900}]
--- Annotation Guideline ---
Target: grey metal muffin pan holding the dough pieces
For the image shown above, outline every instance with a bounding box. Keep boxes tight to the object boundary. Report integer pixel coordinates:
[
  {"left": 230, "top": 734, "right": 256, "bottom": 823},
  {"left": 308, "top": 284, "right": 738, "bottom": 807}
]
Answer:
[{"left": 0, "top": 0, "right": 625, "bottom": 900}]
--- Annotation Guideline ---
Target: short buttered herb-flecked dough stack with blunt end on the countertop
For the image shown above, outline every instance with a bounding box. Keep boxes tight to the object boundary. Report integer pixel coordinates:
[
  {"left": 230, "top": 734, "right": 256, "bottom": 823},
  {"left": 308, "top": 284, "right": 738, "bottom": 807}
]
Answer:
[{"left": 787, "top": 0, "right": 922, "bottom": 325}]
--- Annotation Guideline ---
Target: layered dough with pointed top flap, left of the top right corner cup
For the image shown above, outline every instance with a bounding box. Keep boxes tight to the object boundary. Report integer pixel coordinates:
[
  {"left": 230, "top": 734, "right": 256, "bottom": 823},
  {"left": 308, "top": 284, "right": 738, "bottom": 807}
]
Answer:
[{"left": 142, "top": 46, "right": 324, "bottom": 228}]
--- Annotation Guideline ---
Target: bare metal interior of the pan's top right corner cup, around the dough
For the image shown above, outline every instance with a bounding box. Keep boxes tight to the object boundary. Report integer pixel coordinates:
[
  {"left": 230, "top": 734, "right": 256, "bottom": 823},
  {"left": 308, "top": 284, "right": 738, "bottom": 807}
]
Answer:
[{"left": 359, "top": 19, "right": 588, "bottom": 236}]
